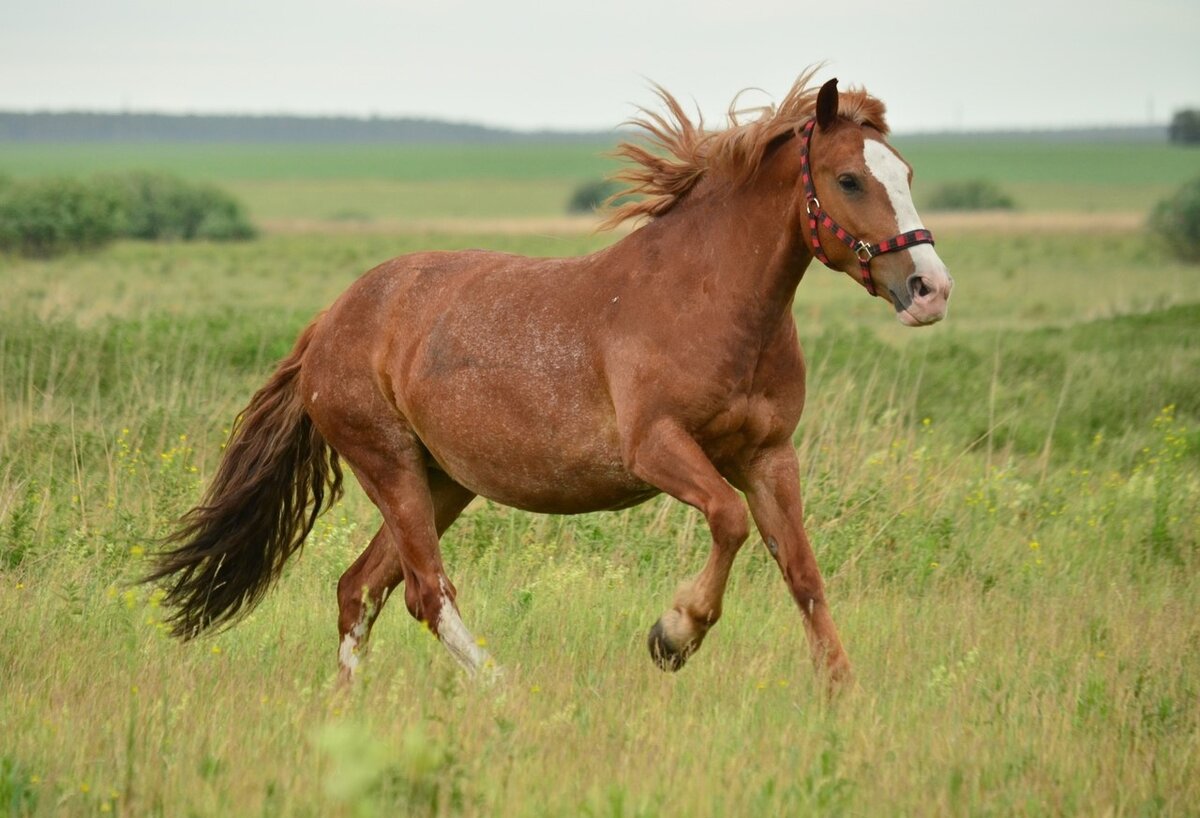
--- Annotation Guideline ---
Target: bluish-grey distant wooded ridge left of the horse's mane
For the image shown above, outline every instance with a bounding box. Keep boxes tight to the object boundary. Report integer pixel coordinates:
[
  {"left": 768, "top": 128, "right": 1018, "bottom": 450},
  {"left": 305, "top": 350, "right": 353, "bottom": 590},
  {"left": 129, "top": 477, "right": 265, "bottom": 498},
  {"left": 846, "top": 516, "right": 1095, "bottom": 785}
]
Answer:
[{"left": 0, "top": 112, "right": 617, "bottom": 145}]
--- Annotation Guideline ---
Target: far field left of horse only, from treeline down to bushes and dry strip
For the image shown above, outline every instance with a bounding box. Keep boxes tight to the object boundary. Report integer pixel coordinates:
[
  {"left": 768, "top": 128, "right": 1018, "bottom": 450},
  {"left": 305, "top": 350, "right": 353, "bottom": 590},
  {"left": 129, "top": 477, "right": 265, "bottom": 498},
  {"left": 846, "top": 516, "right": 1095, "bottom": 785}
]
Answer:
[{"left": 0, "top": 143, "right": 617, "bottom": 223}]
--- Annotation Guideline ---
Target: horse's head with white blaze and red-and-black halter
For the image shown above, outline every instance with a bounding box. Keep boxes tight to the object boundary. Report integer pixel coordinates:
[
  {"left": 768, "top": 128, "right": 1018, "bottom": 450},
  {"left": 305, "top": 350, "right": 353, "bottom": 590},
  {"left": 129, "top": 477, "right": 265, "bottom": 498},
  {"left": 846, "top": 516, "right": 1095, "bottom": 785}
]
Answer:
[{"left": 800, "top": 79, "right": 954, "bottom": 326}]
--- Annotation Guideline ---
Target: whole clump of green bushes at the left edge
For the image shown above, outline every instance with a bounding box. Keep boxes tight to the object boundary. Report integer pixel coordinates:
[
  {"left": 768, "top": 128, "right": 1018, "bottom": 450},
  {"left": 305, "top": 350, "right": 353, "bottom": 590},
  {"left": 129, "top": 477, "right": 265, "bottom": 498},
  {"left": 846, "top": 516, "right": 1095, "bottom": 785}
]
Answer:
[{"left": 0, "top": 173, "right": 254, "bottom": 257}]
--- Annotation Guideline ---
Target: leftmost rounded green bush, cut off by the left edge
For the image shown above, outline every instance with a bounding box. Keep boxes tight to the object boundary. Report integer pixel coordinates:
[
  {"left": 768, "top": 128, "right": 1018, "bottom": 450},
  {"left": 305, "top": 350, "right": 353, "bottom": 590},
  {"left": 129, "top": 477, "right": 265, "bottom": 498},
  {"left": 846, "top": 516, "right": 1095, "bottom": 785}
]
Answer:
[{"left": 0, "top": 179, "right": 120, "bottom": 257}]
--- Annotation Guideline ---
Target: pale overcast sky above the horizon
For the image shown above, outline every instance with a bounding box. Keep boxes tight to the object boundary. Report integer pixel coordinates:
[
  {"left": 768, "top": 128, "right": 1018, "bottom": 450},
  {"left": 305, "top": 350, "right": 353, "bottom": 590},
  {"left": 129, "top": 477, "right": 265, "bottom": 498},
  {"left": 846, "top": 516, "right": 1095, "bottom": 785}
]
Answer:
[{"left": 0, "top": 0, "right": 1200, "bottom": 132}]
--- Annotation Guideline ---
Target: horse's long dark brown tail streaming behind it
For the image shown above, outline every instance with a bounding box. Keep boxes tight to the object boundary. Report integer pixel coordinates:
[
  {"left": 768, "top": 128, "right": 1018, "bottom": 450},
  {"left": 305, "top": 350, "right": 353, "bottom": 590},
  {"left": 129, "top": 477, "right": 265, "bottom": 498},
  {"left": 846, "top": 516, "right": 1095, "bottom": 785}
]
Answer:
[{"left": 142, "top": 319, "right": 342, "bottom": 639}]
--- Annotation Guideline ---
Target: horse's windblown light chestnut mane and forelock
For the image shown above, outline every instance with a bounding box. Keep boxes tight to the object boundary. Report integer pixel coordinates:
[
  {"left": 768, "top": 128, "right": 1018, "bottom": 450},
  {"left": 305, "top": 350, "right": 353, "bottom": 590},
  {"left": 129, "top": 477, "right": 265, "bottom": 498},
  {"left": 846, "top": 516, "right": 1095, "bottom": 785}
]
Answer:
[{"left": 601, "top": 68, "right": 888, "bottom": 229}]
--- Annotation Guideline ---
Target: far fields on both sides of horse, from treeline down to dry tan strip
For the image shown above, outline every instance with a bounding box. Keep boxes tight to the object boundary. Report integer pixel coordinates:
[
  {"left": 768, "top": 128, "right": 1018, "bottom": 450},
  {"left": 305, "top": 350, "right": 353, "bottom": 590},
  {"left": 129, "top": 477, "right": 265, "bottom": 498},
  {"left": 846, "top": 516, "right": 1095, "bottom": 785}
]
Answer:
[{"left": 0, "top": 137, "right": 1200, "bottom": 222}]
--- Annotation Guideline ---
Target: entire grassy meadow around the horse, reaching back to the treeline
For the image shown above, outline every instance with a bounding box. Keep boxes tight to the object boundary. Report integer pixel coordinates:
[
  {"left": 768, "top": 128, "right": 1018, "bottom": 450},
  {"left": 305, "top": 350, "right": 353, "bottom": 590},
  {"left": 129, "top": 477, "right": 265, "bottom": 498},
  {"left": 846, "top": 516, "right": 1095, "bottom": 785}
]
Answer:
[{"left": 0, "top": 136, "right": 1200, "bottom": 818}]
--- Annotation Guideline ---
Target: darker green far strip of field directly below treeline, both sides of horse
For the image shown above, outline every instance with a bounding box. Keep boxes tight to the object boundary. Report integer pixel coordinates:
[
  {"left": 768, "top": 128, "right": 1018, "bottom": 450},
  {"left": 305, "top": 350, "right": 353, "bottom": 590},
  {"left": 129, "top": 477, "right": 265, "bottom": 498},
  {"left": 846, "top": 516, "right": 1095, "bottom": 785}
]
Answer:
[{"left": 0, "top": 136, "right": 1200, "bottom": 186}]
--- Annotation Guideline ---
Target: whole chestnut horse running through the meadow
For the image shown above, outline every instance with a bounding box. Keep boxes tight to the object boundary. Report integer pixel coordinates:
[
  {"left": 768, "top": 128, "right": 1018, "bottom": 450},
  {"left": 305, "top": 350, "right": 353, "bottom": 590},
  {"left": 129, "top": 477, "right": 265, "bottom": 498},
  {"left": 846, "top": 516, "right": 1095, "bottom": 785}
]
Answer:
[{"left": 146, "top": 71, "right": 953, "bottom": 681}]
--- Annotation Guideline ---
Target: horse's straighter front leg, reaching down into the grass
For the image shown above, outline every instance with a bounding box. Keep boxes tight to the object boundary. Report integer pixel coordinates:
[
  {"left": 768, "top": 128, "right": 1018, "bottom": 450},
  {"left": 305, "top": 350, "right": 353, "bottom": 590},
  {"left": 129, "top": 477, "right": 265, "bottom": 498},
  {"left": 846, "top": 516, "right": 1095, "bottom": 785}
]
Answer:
[{"left": 745, "top": 441, "right": 851, "bottom": 685}]
